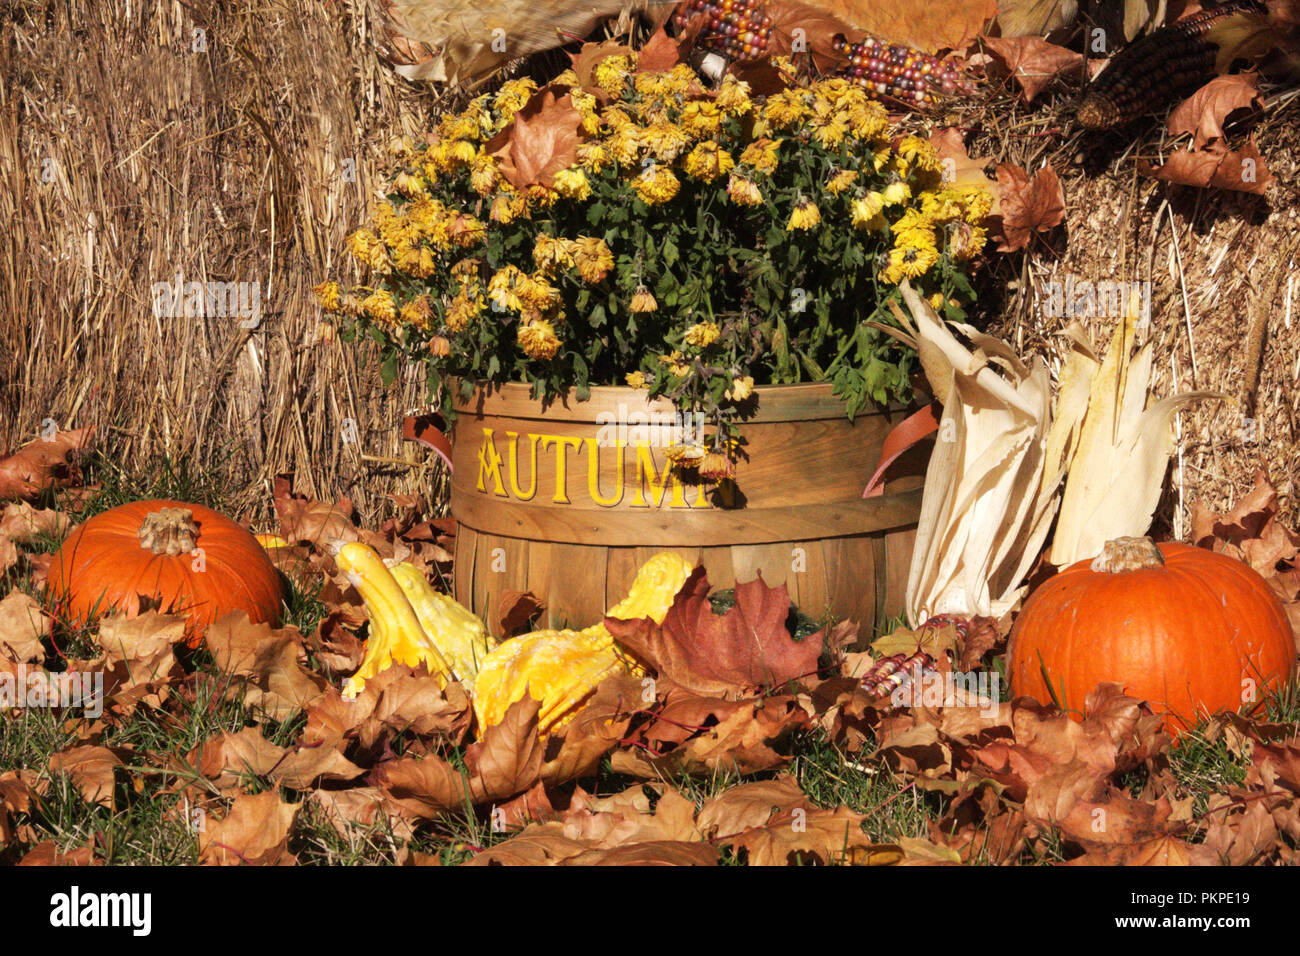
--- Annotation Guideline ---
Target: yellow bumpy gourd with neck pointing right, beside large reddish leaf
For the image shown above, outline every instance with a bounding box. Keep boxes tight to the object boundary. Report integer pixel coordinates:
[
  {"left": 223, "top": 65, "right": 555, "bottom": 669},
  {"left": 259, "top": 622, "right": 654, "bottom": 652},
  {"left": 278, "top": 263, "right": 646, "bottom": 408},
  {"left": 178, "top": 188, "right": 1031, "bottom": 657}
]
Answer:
[{"left": 472, "top": 551, "right": 692, "bottom": 734}]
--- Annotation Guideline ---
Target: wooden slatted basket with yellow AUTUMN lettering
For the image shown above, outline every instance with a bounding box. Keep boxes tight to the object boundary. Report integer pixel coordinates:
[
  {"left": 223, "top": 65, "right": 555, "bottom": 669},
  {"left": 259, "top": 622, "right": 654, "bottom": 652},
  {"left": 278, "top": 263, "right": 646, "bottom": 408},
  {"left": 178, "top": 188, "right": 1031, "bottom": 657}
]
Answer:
[{"left": 451, "top": 384, "right": 930, "bottom": 628}]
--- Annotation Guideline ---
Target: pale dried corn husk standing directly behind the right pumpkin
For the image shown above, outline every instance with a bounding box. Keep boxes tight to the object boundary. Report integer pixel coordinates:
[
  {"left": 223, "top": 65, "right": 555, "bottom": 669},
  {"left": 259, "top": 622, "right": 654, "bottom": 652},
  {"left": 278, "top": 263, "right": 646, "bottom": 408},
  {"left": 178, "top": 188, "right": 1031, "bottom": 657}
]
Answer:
[{"left": 1049, "top": 300, "right": 1223, "bottom": 567}]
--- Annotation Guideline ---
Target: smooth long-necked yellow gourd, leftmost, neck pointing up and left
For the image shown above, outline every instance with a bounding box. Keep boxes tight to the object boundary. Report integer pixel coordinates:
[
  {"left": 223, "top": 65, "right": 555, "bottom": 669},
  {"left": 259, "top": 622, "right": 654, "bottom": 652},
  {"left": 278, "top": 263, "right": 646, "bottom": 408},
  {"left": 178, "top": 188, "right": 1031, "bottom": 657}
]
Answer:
[{"left": 335, "top": 541, "right": 455, "bottom": 700}]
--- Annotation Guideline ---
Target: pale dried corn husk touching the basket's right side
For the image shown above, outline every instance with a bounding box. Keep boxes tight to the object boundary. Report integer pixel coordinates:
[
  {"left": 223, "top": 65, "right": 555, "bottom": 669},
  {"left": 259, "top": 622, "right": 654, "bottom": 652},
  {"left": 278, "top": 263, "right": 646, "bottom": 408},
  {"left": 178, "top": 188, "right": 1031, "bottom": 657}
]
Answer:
[{"left": 897, "top": 284, "right": 1071, "bottom": 627}]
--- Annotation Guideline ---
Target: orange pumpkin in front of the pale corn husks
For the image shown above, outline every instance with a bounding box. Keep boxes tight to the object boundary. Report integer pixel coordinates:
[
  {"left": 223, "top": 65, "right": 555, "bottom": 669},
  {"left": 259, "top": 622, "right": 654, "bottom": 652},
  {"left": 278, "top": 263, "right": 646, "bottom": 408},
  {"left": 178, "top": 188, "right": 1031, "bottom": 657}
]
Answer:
[{"left": 1006, "top": 537, "right": 1296, "bottom": 736}]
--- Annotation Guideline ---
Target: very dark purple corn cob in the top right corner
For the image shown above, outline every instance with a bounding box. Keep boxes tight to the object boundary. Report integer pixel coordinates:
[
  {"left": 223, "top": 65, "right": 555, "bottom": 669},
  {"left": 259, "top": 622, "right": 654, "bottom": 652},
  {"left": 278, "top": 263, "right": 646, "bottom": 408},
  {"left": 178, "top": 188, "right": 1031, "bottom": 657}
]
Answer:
[{"left": 1076, "top": 0, "right": 1260, "bottom": 130}]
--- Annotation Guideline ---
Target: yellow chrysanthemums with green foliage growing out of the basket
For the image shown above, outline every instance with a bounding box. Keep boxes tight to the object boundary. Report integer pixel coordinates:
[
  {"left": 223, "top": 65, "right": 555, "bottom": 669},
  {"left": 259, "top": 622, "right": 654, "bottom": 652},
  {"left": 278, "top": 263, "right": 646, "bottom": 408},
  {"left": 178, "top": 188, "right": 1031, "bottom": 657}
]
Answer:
[{"left": 317, "top": 52, "right": 992, "bottom": 468}]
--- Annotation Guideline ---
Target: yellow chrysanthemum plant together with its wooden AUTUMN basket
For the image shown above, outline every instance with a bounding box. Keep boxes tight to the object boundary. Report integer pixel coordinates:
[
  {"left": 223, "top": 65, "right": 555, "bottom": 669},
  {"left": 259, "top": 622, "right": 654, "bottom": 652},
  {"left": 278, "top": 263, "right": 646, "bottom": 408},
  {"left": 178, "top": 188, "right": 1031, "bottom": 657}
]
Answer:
[{"left": 317, "top": 48, "right": 992, "bottom": 634}]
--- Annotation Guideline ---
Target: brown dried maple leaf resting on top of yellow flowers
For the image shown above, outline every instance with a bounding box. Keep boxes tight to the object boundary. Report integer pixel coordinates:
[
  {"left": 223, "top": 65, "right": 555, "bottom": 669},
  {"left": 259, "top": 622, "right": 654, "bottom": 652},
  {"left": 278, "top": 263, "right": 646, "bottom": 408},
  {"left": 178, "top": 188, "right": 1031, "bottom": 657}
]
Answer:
[{"left": 484, "top": 85, "right": 586, "bottom": 190}]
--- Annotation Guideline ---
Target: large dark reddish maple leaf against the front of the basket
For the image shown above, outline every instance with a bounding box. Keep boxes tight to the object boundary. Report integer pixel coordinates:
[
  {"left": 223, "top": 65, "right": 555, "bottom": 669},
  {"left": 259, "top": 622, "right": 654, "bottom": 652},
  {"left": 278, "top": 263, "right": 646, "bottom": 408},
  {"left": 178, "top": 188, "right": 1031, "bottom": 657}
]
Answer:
[{"left": 605, "top": 567, "right": 822, "bottom": 695}]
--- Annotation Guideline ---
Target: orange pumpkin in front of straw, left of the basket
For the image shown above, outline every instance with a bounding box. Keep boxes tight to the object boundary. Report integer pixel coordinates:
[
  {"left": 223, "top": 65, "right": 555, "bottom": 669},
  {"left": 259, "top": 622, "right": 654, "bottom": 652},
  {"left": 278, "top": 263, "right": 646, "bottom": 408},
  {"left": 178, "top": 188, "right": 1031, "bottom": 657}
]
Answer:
[{"left": 47, "top": 501, "right": 283, "bottom": 646}]
